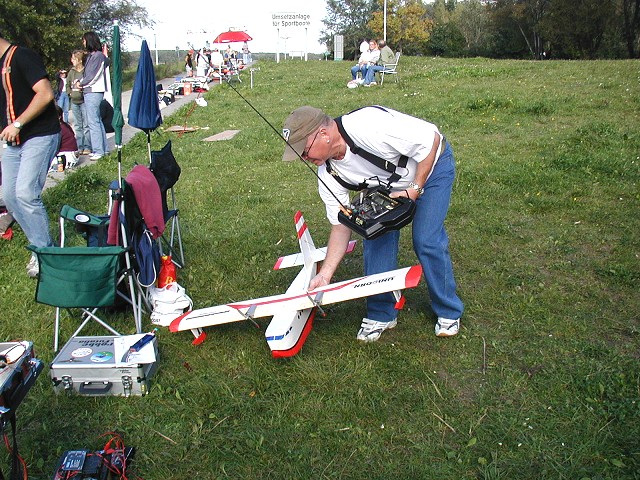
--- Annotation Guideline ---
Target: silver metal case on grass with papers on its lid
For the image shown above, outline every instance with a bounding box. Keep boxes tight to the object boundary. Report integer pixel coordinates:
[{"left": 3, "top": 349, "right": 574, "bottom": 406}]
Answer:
[{"left": 49, "top": 335, "right": 158, "bottom": 397}]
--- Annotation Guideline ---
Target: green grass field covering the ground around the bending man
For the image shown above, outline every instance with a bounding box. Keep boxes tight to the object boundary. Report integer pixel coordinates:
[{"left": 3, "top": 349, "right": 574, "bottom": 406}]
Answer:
[{"left": 0, "top": 57, "right": 640, "bottom": 480}]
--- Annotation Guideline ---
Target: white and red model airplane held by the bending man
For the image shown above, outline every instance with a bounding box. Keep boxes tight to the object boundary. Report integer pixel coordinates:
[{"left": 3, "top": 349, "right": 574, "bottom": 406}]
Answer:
[{"left": 169, "top": 212, "right": 422, "bottom": 357}]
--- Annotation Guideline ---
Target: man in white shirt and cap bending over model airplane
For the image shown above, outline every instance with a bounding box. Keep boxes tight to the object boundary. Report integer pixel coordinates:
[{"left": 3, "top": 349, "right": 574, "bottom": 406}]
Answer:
[{"left": 283, "top": 106, "right": 464, "bottom": 342}]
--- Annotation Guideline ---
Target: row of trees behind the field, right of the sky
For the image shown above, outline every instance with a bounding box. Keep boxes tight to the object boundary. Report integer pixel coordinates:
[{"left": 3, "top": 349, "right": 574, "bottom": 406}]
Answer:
[{"left": 320, "top": 0, "right": 640, "bottom": 60}]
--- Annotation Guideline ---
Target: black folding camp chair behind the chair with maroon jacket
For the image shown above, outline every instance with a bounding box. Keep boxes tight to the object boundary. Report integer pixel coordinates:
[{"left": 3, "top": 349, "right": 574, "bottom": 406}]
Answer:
[{"left": 149, "top": 140, "right": 185, "bottom": 268}]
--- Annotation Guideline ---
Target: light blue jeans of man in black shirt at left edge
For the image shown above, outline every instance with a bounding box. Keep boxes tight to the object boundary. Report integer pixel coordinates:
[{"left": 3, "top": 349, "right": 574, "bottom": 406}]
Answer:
[{"left": 2, "top": 133, "right": 60, "bottom": 247}]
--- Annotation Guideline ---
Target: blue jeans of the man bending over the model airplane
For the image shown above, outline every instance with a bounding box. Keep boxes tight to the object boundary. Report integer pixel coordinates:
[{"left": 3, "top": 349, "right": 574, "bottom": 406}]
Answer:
[{"left": 364, "top": 143, "right": 464, "bottom": 322}]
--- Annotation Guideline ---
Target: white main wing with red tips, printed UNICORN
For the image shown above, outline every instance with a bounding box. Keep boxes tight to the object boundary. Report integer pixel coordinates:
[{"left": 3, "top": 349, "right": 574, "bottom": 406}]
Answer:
[{"left": 169, "top": 265, "right": 422, "bottom": 332}]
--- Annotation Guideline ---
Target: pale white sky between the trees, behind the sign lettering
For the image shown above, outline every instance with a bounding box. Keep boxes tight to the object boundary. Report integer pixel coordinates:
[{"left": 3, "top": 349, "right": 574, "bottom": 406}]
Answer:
[{"left": 125, "top": 0, "right": 326, "bottom": 54}]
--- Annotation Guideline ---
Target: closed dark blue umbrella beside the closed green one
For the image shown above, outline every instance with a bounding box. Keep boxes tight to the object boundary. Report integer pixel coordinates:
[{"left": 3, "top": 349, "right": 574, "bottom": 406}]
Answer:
[{"left": 129, "top": 40, "right": 162, "bottom": 161}]
